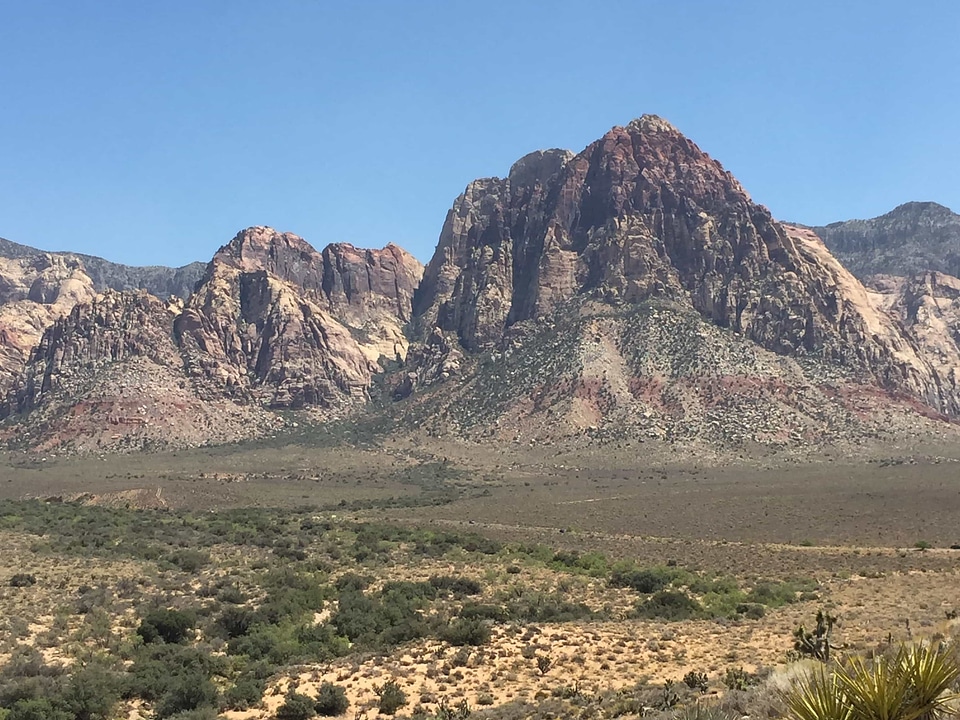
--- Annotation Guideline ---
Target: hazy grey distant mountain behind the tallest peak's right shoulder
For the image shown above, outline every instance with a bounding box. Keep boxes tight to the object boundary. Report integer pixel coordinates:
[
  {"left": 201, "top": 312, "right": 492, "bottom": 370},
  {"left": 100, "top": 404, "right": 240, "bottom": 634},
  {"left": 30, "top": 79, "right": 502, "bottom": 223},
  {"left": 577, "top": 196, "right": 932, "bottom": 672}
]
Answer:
[{"left": 813, "top": 202, "right": 960, "bottom": 278}]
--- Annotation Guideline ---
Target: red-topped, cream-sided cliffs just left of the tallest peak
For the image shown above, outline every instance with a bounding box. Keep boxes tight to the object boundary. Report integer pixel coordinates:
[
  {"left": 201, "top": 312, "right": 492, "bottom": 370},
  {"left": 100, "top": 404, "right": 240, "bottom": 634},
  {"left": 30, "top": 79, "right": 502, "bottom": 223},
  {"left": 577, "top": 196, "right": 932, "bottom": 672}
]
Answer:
[{"left": 175, "top": 228, "right": 421, "bottom": 409}]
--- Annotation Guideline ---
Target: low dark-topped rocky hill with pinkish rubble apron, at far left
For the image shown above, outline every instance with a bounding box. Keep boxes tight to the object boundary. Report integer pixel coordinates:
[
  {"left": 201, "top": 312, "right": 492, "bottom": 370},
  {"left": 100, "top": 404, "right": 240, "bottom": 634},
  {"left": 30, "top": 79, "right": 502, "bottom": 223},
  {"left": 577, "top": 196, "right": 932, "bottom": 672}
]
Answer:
[{"left": 4, "top": 290, "right": 277, "bottom": 453}]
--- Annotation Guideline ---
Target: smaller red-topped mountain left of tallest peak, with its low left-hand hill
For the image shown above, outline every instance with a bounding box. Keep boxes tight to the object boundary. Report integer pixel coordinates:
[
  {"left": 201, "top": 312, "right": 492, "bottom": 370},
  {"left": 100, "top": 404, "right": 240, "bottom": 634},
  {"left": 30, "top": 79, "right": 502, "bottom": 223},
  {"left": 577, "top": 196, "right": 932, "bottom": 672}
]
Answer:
[{"left": 0, "top": 227, "right": 422, "bottom": 451}]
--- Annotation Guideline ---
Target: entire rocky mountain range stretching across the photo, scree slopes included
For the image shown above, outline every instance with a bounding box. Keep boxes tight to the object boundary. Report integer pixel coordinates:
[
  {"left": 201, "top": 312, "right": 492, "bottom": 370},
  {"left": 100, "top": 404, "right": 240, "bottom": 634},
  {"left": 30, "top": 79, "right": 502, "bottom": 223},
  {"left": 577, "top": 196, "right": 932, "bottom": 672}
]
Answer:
[{"left": 0, "top": 115, "right": 960, "bottom": 453}]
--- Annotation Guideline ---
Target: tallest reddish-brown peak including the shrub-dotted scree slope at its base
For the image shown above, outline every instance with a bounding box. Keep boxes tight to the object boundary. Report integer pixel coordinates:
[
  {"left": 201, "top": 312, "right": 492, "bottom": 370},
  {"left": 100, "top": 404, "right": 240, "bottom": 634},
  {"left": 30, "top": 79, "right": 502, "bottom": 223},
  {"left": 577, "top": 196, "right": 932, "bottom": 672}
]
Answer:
[{"left": 406, "top": 116, "right": 958, "bottom": 442}]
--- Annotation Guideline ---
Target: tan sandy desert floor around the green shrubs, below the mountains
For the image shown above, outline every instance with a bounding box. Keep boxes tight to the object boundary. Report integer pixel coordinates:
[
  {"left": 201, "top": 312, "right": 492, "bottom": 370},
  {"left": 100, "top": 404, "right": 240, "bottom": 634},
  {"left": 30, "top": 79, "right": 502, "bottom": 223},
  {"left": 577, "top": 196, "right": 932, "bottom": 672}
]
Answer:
[{"left": 0, "top": 434, "right": 960, "bottom": 719}]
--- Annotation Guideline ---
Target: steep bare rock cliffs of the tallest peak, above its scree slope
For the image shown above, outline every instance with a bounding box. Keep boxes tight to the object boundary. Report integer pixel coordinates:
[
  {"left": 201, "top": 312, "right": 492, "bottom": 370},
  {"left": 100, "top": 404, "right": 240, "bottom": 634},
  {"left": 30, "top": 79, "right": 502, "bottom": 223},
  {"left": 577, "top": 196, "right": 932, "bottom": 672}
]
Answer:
[{"left": 414, "top": 116, "right": 955, "bottom": 420}]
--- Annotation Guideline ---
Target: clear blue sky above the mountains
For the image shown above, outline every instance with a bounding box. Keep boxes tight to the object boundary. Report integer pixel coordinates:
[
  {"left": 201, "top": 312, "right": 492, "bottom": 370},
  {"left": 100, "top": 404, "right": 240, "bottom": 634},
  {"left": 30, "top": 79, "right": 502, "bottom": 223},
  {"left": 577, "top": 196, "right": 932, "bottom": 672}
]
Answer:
[{"left": 0, "top": 0, "right": 960, "bottom": 264}]
